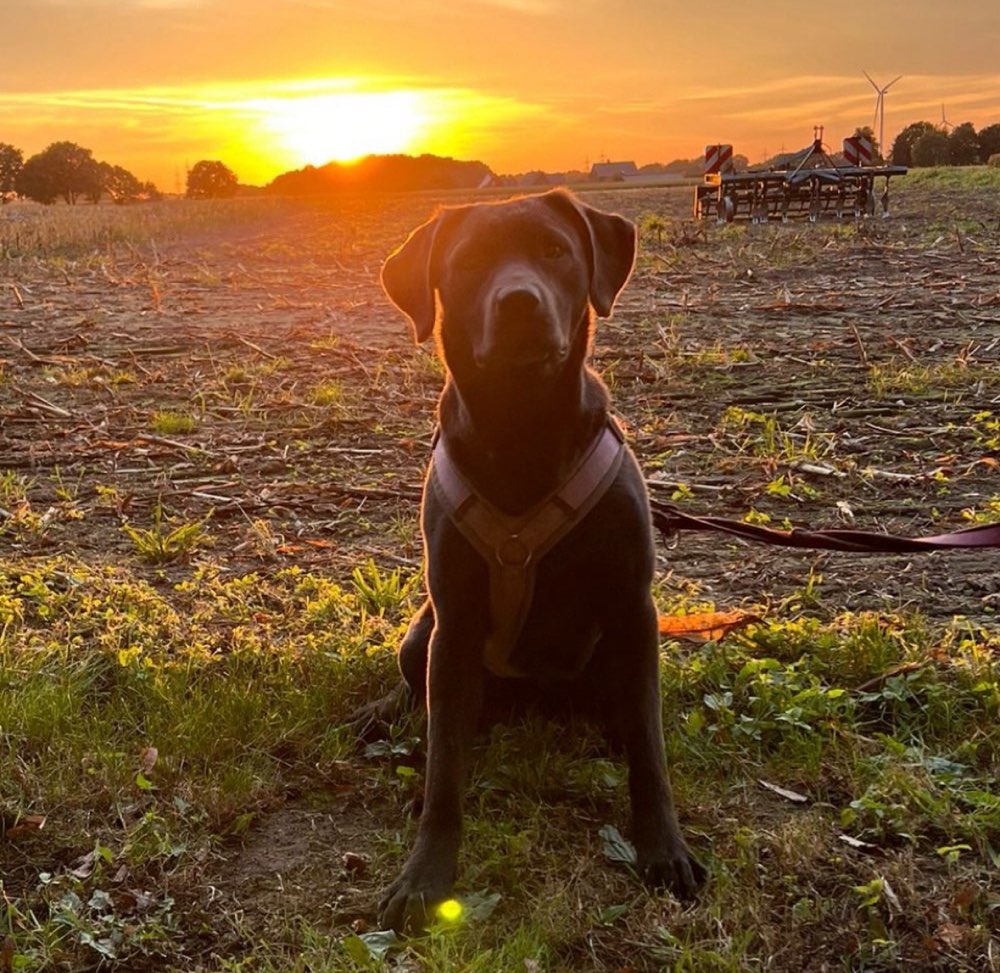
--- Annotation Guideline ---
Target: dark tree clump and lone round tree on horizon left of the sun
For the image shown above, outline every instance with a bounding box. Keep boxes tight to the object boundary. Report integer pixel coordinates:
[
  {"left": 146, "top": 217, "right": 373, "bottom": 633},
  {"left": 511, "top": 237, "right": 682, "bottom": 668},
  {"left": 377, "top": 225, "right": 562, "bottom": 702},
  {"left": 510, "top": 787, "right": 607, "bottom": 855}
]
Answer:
[{"left": 0, "top": 142, "right": 239, "bottom": 205}]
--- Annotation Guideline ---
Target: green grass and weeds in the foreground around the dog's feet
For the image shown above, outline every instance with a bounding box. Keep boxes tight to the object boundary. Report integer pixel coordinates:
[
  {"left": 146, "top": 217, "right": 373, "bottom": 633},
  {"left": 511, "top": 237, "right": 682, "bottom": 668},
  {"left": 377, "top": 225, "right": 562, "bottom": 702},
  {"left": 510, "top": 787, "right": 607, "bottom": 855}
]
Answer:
[{"left": 0, "top": 559, "right": 1000, "bottom": 973}]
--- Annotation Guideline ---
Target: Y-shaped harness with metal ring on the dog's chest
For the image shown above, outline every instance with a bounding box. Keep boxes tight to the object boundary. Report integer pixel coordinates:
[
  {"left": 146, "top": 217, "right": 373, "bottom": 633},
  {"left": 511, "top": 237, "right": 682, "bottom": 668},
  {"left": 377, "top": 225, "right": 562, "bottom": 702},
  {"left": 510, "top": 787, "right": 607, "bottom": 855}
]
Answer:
[{"left": 429, "top": 417, "right": 625, "bottom": 676}]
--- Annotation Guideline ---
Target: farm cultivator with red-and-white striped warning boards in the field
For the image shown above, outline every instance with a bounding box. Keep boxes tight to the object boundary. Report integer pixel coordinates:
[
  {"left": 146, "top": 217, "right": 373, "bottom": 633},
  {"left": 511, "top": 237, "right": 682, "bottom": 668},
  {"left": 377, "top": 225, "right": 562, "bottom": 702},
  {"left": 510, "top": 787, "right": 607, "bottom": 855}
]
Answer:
[{"left": 694, "top": 128, "right": 907, "bottom": 223}]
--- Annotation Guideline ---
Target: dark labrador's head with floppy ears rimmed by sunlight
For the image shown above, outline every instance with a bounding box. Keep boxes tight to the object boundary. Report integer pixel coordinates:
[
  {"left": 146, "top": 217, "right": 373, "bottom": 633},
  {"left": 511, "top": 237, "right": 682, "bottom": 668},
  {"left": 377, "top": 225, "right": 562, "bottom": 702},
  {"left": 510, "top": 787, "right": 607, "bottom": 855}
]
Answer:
[{"left": 382, "top": 191, "right": 636, "bottom": 371}]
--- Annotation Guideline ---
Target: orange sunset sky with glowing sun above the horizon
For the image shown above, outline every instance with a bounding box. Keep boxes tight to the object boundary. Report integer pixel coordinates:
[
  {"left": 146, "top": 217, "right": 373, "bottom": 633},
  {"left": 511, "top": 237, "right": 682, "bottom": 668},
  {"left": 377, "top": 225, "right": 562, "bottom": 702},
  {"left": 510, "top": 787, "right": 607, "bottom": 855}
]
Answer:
[{"left": 0, "top": 0, "right": 1000, "bottom": 191}]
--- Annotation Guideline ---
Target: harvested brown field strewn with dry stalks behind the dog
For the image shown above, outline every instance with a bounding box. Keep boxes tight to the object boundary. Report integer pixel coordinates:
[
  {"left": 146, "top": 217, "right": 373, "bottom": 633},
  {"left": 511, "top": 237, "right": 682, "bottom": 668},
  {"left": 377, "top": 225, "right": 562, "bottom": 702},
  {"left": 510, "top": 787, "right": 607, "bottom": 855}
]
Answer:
[{"left": 0, "top": 180, "right": 1000, "bottom": 621}]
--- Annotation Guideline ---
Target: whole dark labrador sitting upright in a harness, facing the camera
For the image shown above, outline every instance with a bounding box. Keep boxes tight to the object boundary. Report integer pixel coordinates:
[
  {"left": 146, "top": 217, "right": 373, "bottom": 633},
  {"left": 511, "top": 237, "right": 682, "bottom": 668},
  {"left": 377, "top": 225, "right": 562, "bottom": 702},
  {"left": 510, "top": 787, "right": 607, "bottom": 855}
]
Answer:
[{"left": 369, "top": 191, "right": 705, "bottom": 930}]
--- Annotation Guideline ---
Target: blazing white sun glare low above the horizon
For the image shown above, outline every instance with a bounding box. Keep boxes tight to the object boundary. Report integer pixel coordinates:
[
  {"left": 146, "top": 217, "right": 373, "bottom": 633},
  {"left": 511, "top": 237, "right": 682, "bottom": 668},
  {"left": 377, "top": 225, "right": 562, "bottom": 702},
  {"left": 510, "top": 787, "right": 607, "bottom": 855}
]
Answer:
[{"left": 256, "top": 91, "right": 429, "bottom": 165}]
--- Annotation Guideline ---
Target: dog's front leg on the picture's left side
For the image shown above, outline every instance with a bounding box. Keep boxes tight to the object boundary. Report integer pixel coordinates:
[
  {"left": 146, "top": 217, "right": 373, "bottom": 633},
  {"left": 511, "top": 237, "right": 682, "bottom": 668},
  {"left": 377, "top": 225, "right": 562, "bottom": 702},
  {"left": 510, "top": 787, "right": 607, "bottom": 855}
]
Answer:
[{"left": 379, "top": 625, "right": 483, "bottom": 932}]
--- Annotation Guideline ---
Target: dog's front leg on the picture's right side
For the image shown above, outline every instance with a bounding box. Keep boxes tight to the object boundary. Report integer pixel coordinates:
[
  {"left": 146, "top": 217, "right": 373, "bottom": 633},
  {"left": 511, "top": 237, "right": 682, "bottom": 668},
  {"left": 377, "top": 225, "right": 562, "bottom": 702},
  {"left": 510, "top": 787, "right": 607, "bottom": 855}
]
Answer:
[{"left": 615, "top": 601, "right": 705, "bottom": 898}]
